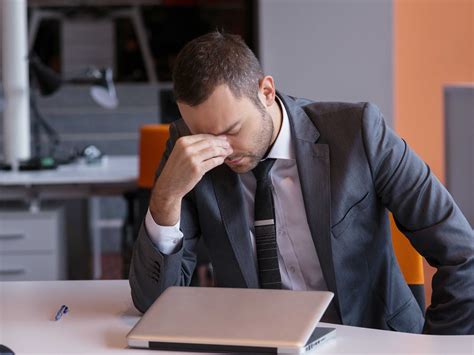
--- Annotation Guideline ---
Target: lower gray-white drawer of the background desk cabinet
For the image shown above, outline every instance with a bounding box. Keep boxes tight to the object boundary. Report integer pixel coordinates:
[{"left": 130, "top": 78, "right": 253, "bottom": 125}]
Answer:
[{"left": 0, "top": 253, "right": 62, "bottom": 281}]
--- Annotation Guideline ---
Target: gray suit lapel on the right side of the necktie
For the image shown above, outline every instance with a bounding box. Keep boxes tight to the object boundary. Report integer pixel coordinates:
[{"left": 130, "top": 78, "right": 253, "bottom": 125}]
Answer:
[{"left": 278, "top": 93, "right": 339, "bottom": 318}]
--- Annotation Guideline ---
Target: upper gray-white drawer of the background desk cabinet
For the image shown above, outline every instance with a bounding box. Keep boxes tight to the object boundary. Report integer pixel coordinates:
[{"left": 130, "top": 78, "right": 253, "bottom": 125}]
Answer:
[{"left": 0, "top": 211, "right": 61, "bottom": 254}]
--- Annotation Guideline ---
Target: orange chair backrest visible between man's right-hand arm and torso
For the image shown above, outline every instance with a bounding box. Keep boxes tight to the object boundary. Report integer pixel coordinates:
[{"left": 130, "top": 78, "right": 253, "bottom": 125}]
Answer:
[{"left": 390, "top": 214, "right": 425, "bottom": 312}]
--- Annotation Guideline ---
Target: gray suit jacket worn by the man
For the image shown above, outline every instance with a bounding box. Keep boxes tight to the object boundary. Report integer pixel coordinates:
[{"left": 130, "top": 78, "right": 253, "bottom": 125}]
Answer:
[{"left": 130, "top": 94, "right": 474, "bottom": 334}]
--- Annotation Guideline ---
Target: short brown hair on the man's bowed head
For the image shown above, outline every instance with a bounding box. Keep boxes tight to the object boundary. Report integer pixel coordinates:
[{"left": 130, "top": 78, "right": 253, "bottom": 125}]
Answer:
[{"left": 173, "top": 31, "right": 264, "bottom": 107}]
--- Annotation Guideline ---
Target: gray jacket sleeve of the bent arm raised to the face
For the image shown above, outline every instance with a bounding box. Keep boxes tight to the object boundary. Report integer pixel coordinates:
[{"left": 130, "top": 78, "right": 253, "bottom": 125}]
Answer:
[{"left": 129, "top": 124, "right": 200, "bottom": 312}]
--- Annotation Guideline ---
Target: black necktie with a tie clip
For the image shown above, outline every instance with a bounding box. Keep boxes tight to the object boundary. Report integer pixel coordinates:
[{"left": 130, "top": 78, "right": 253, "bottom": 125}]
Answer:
[{"left": 252, "top": 159, "right": 281, "bottom": 289}]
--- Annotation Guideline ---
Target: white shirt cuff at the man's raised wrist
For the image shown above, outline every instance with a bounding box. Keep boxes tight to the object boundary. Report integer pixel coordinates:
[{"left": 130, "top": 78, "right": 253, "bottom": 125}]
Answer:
[{"left": 145, "top": 209, "right": 183, "bottom": 255}]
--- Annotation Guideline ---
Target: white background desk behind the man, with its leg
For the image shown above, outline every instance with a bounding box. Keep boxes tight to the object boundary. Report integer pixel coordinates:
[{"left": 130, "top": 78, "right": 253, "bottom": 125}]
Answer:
[{"left": 0, "top": 156, "right": 138, "bottom": 279}]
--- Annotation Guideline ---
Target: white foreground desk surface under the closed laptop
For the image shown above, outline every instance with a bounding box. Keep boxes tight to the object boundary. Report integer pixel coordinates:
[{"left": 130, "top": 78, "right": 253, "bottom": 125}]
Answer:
[{"left": 0, "top": 280, "right": 474, "bottom": 355}]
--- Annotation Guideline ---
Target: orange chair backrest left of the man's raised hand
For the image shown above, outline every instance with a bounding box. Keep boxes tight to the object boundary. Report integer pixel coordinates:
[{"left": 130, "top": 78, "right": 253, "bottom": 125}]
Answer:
[{"left": 138, "top": 124, "right": 169, "bottom": 189}]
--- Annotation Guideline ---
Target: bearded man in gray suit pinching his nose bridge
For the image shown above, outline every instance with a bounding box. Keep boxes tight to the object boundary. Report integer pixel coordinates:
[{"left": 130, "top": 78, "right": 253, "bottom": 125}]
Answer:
[{"left": 130, "top": 32, "right": 474, "bottom": 334}]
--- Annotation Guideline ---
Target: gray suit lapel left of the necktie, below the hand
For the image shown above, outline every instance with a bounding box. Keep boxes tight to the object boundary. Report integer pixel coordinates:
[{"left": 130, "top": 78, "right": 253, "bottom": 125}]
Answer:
[{"left": 211, "top": 165, "right": 258, "bottom": 288}]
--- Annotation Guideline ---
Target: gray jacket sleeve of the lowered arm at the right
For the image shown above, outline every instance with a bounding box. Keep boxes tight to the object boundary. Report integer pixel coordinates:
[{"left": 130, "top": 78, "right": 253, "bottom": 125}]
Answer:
[{"left": 362, "top": 104, "right": 474, "bottom": 334}]
